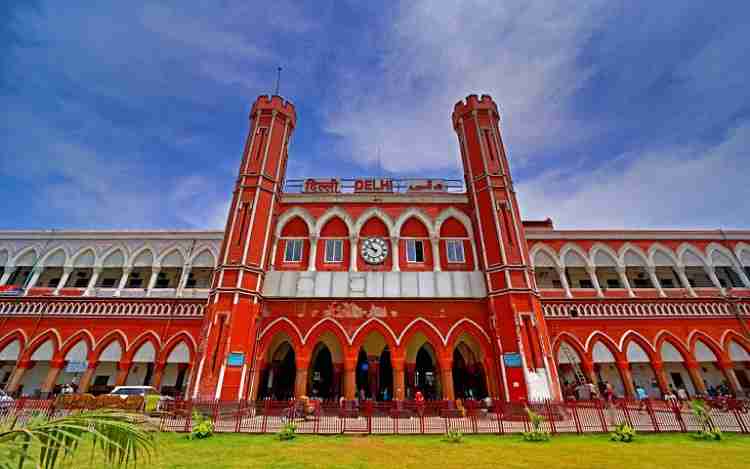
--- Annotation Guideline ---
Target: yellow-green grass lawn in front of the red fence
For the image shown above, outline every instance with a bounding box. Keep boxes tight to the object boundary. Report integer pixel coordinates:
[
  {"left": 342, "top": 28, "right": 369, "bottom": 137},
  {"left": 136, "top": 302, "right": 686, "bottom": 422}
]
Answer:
[{"left": 73, "top": 433, "right": 750, "bottom": 469}]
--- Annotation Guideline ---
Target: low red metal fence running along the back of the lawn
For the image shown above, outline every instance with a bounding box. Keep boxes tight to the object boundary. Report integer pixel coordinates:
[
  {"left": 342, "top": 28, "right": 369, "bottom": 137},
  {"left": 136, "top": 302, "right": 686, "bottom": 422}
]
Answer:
[{"left": 0, "top": 399, "right": 750, "bottom": 435}]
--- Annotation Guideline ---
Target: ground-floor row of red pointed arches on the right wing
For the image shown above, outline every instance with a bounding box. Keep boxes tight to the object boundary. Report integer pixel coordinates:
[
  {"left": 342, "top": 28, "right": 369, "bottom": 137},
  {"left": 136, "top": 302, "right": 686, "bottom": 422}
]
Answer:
[{"left": 554, "top": 330, "right": 750, "bottom": 399}]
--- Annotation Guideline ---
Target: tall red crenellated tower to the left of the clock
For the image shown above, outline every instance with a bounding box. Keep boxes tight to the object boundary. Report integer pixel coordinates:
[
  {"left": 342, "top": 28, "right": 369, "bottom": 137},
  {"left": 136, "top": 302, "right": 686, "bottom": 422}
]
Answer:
[{"left": 191, "top": 96, "right": 297, "bottom": 400}]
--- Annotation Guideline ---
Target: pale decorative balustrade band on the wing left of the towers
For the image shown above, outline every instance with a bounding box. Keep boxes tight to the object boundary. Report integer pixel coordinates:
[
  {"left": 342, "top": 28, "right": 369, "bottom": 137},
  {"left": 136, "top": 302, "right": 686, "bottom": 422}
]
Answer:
[{"left": 0, "top": 297, "right": 206, "bottom": 318}]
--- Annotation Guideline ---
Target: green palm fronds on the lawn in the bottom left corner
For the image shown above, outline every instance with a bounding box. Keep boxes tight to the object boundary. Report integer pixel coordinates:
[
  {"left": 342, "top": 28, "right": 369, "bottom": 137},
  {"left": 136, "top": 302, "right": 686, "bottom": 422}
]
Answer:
[{"left": 0, "top": 411, "right": 154, "bottom": 469}]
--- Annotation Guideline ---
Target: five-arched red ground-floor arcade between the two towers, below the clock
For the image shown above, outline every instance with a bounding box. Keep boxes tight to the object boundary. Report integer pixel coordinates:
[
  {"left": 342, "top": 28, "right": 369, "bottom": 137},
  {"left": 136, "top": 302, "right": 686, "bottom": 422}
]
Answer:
[{"left": 249, "top": 320, "right": 500, "bottom": 400}]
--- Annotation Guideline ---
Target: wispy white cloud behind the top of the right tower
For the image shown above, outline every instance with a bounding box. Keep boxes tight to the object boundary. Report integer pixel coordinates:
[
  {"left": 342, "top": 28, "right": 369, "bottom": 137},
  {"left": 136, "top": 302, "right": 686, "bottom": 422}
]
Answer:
[{"left": 326, "top": 0, "right": 603, "bottom": 171}]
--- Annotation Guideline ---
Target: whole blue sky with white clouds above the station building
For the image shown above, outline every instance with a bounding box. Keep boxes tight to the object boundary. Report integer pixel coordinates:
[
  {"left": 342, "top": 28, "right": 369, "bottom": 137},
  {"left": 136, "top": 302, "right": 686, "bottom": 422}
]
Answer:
[{"left": 0, "top": 0, "right": 750, "bottom": 229}]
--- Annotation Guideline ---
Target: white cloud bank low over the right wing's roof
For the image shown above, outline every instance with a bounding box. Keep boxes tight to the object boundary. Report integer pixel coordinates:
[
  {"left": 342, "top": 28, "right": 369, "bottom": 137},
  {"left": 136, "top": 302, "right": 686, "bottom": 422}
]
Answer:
[{"left": 516, "top": 121, "right": 750, "bottom": 229}]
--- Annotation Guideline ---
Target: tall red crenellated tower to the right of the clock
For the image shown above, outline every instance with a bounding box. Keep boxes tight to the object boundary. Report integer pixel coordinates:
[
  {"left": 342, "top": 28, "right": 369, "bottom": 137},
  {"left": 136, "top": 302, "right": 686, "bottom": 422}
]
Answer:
[{"left": 453, "top": 95, "right": 561, "bottom": 401}]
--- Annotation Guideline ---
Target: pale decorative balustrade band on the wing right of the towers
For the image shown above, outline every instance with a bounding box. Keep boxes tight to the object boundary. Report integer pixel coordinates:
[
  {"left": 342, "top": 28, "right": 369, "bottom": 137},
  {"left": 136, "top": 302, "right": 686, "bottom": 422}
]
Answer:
[{"left": 542, "top": 299, "right": 750, "bottom": 319}]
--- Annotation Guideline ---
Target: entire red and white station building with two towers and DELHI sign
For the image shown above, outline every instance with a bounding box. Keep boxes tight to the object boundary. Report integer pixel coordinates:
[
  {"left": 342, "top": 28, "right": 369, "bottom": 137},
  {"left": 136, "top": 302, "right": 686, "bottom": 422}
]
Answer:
[{"left": 0, "top": 95, "right": 750, "bottom": 400}]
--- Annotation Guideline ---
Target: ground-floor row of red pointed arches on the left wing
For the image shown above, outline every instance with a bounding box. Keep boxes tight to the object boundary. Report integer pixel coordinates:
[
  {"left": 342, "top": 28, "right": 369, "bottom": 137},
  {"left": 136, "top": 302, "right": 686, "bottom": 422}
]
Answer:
[{"left": 0, "top": 330, "right": 196, "bottom": 396}]
